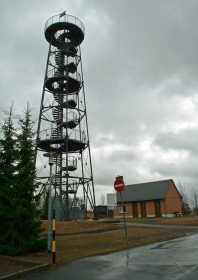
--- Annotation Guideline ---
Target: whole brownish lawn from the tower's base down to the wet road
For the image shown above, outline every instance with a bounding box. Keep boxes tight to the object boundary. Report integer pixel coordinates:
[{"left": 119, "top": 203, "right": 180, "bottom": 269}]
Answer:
[{"left": 0, "top": 221, "right": 198, "bottom": 272}]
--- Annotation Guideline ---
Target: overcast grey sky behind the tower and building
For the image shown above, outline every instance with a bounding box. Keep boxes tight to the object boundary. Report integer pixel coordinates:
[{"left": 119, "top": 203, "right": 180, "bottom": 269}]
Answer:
[{"left": 0, "top": 0, "right": 198, "bottom": 201}]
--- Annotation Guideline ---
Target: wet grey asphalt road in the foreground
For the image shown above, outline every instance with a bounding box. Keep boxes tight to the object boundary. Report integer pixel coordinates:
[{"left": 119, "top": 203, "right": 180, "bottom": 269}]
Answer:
[{"left": 24, "top": 234, "right": 198, "bottom": 280}]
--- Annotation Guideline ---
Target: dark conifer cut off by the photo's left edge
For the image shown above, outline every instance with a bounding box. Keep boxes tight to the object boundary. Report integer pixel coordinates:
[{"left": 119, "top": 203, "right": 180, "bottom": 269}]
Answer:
[{"left": 0, "top": 107, "right": 17, "bottom": 252}]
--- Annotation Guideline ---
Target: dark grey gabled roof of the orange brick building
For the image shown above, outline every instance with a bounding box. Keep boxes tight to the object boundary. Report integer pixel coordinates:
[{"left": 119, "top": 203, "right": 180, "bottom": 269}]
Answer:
[{"left": 117, "top": 179, "right": 175, "bottom": 203}]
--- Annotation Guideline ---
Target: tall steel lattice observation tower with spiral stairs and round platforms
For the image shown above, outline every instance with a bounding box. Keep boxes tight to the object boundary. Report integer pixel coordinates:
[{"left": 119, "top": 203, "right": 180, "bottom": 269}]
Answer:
[{"left": 35, "top": 12, "right": 95, "bottom": 219}]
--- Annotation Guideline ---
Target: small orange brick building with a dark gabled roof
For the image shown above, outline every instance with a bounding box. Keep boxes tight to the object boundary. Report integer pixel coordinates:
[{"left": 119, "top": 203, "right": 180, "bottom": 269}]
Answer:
[{"left": 114, "top": 179, "right": 183, "bottom": 218}]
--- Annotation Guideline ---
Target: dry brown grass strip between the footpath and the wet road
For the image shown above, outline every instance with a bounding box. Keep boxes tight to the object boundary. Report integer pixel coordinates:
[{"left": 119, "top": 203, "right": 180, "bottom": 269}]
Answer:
[{"left": 23, "top": 221, "right": 196, "bottom": 264}]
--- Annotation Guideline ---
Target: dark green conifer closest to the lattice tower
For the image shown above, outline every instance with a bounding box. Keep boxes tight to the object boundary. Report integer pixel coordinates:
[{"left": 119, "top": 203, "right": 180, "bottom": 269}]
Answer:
[{"left": 15, "top": 106, "right": 40, "bottom": 250}]
